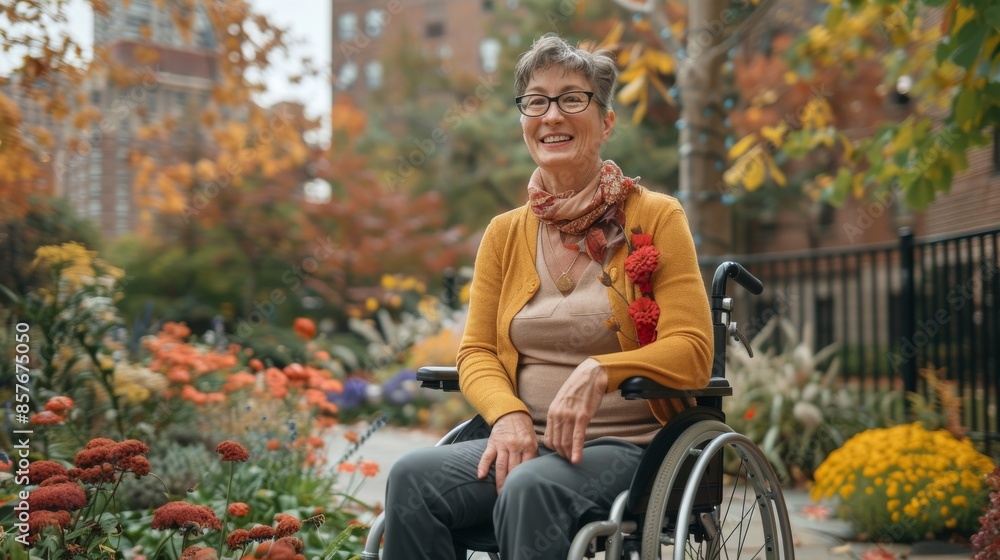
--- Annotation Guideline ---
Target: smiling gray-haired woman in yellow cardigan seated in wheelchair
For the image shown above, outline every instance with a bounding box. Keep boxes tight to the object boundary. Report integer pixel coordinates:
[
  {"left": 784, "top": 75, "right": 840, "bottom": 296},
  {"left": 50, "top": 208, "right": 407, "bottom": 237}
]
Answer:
[{"left": 383, "top": 31, "right": 712, "bottom": 560}]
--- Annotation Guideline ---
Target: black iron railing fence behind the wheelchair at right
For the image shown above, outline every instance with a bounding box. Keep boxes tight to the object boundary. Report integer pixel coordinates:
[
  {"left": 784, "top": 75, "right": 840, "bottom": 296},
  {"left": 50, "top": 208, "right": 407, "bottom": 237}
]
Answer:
[{"left": 702, "top": 228, "right": 1000, "bottom": 453}]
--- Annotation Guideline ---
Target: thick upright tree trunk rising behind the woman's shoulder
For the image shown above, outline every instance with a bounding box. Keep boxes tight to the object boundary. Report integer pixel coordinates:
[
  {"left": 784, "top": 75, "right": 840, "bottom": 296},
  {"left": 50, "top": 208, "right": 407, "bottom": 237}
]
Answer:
[{"left": 678, "top": 0, "right": 734, "bottom": 256}]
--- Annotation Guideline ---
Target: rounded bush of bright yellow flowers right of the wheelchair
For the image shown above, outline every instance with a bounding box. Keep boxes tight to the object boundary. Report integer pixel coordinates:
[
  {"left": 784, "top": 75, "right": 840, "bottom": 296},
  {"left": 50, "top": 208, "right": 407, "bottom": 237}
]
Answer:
[{"left": 812, "top": 422, "right": 994, "bottom": 542}]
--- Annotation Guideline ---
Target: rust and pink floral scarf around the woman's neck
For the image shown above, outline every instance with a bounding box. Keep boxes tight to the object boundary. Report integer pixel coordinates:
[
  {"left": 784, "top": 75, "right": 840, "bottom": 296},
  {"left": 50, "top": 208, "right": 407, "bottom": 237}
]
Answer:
[{"left": 528, "top": 159, "right": 639, "bottom": 264}]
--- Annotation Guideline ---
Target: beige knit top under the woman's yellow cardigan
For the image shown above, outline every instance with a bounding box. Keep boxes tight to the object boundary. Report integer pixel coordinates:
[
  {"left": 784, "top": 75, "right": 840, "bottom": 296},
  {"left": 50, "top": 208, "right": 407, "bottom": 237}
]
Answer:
[{"left": 510, "top": 230, "right": 661, "bottom": 445}]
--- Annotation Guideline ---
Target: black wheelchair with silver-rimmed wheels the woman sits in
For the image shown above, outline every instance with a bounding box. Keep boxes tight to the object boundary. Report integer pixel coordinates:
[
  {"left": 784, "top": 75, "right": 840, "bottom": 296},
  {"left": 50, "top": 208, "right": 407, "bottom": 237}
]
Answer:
[{"left": 361, "top": 261, "right": 795, "bottom": 560}]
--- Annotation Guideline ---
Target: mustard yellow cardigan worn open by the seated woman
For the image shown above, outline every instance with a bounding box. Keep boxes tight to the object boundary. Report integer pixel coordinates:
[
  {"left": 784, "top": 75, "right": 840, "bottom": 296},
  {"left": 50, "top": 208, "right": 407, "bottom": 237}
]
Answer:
[{"left": 458, "top": 187, "right": 713, "bottom": 425}]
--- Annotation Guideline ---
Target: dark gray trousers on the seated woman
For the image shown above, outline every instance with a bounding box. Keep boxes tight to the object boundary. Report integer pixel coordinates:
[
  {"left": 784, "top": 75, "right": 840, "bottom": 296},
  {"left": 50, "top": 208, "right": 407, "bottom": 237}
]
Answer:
[{"left": 382, "top": 438, "right": 643, "bottom": 560}]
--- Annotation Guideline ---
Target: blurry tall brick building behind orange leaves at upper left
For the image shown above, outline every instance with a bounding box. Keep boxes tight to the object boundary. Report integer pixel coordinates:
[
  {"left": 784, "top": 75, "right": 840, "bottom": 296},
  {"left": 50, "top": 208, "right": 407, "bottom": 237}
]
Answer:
[{"left": 54, "top": 0, "right": 218, "bottom": 238}]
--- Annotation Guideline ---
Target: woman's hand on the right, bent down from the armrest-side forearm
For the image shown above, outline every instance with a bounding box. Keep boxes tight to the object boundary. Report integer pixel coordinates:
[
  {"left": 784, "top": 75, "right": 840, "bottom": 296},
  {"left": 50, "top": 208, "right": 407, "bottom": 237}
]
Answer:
[{"left": 545, "top": 358, "right": 608, "bottom": 464}]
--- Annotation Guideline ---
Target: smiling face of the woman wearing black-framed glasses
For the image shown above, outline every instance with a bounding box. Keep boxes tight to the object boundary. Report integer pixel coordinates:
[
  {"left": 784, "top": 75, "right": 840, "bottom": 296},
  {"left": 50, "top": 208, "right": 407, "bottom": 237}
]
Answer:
[{"left": 521, "top": 66, "right": 615, "bottom": 178}]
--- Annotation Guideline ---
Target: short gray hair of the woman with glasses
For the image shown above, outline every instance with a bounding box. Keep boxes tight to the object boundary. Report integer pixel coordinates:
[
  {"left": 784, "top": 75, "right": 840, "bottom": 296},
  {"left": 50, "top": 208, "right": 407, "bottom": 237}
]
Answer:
[{"left": 514, "top": 33, "right": 618, "bottom": 116}]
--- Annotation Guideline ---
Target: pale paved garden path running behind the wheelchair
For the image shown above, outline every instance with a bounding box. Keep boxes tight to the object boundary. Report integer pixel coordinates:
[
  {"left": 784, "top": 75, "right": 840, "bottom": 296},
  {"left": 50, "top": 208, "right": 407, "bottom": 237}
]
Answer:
[{"left": 330, "top": 427, "right": 972, "bottom": 560}]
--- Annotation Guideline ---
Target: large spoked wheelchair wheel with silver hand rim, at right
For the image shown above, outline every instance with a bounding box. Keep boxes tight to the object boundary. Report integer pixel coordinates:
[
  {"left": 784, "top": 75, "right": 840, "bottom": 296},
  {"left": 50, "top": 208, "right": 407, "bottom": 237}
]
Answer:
[{"left": 641, "top": 420, "right": 795, "bottom": 560}]
